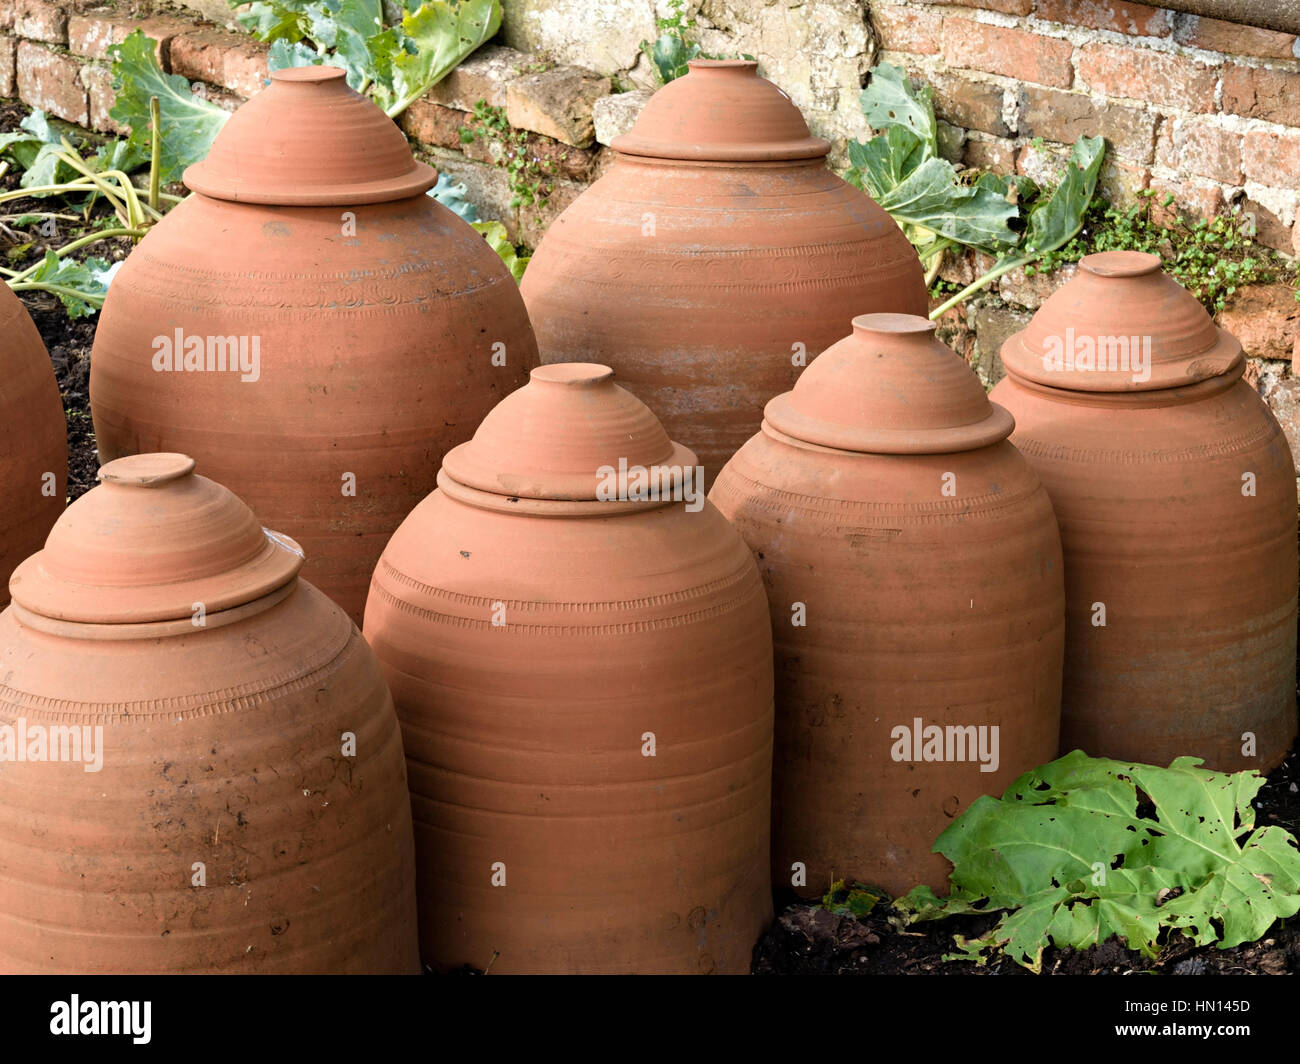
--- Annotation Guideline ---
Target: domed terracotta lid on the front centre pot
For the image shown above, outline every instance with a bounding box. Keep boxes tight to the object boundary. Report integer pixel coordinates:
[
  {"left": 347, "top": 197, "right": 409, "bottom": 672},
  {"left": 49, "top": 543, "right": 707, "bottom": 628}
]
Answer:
[{"left": 442, "top": 362, "right": 696, "bottom": 502}]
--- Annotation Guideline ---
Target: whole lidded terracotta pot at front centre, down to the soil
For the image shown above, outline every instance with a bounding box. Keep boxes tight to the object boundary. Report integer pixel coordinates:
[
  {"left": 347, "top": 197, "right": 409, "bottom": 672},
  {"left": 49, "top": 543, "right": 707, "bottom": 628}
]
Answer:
[{"left": 365, "top": 364, "right": 772, "bottom": 973}]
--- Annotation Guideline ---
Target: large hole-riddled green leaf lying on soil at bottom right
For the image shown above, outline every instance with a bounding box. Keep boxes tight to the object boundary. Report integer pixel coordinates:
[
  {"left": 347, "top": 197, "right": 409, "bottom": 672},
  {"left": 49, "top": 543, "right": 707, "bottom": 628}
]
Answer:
[{"left": 896, "top": 751, "right": 1300, "bottom": 970}]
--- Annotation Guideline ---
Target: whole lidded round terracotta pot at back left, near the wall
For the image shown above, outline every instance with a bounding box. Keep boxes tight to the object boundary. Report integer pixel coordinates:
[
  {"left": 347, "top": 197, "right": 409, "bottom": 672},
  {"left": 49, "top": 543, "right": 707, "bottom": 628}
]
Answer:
[{"left": 91, "top": 68, "right": 536, "bottom": 623}]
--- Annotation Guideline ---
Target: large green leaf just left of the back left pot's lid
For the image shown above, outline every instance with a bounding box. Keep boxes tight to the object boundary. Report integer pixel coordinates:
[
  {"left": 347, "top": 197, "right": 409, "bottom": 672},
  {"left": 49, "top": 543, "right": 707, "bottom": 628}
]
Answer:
[{"left": 108, "top": 30, "right": 230, "bottom": 183}]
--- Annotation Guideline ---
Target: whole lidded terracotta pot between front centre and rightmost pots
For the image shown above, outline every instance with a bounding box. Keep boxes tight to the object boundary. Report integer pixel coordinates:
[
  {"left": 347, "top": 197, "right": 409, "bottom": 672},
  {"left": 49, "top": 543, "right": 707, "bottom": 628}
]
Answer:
[{"left": 710, "top": 313, "right": 1065, "bottom": 896}]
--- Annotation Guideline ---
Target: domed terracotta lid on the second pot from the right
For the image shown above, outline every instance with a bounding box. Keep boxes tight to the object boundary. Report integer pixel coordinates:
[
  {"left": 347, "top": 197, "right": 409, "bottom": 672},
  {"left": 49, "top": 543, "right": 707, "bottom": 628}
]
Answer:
[{"left": 763, "top": 313, "right": 1015, "bottom": 454}]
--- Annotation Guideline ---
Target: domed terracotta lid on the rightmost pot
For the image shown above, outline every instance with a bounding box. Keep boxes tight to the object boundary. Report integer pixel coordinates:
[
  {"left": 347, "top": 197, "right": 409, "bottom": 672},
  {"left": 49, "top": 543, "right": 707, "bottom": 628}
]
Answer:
[{"left": 1002, "top": 251, "right": 1242, "bottom": 392}]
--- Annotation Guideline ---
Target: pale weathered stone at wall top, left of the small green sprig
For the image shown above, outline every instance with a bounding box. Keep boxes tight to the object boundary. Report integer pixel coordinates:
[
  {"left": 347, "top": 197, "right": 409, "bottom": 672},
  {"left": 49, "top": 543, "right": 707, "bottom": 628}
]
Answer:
[{"left": 501, "top": 0, "right": 658, "bottom": 74}]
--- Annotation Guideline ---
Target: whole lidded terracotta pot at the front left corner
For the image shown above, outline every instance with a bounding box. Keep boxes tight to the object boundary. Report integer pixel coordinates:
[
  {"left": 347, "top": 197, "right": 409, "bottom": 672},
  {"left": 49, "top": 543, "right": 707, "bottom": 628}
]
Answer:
[{"left": 0, "top": 455, "right": 419, "bottom": 973}]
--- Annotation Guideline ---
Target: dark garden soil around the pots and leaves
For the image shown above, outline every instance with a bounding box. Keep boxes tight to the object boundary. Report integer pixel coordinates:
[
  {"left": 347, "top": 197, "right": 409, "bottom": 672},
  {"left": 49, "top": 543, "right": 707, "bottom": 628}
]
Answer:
[{"left": 0, "top": 100, "right": 1300, "bottom": 976}]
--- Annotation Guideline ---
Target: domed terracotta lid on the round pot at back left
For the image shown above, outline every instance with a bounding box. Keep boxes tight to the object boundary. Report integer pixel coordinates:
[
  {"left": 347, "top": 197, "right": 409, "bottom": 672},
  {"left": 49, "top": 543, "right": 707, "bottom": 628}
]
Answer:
[{"left": 185, "top": 66, "right": 438, "bottom": 207}]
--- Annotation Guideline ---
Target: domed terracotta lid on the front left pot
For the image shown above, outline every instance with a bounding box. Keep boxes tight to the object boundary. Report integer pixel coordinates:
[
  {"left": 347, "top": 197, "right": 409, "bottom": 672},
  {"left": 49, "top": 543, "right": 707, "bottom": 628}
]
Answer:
[{"left": 9, "top": 454, "right": 303, "bottom": 624}]
